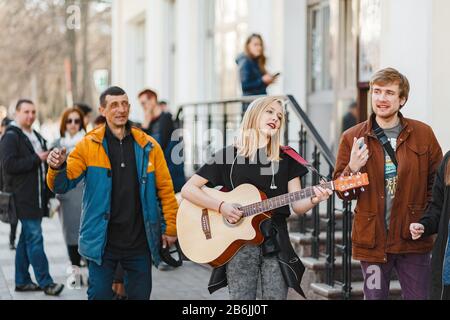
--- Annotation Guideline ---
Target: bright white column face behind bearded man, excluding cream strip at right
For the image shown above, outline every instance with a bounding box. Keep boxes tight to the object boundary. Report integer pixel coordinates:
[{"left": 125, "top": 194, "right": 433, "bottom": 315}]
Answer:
[{"left": 380, "top": 0, "right": 432, "bottom": 124}]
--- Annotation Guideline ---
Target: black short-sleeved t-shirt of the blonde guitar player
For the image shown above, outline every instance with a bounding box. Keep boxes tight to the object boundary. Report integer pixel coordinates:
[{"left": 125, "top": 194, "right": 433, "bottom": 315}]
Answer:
[{"left": 197, "top": 146, "right": 308, "bottom": 217}]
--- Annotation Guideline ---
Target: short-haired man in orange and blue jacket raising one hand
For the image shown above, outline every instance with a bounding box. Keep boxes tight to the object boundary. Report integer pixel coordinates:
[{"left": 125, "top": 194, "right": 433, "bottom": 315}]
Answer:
[{"left": 47, "top": 87, "right": 178, "bottom": 300}]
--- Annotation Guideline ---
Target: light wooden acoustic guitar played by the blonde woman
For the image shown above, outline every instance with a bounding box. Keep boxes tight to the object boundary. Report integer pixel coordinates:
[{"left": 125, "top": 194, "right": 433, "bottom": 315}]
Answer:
[{"left": 177, "top": 173, "right": 369, "bottom": 267}]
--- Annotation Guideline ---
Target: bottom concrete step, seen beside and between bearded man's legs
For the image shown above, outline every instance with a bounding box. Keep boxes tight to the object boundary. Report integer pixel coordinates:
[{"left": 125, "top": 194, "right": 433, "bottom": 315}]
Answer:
[{"left": 309, "top": 280, "right": 401, "bottom": 300}]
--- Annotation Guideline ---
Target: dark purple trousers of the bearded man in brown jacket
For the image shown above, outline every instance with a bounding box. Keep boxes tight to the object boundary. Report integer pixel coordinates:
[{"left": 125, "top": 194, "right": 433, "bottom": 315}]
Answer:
[{"left": 361, "top": 253, "right": 431, "bottom": 300}]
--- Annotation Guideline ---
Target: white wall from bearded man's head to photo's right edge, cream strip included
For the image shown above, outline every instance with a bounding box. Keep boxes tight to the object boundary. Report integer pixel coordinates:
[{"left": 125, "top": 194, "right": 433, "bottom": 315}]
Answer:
[{"left": 380, "top": 0, "right": 450, "bottom": 152}]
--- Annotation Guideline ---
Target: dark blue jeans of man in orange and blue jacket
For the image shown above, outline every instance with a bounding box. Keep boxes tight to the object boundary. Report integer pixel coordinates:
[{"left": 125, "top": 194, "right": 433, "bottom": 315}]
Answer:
[{"left": 87, "top": 250, "right": 152, "bottom": 300}]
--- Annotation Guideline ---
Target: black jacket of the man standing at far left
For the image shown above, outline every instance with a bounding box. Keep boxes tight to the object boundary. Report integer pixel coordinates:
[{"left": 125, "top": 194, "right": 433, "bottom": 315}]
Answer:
[{"left": 0, "top": 126, "right": 51, "bottom": 219}]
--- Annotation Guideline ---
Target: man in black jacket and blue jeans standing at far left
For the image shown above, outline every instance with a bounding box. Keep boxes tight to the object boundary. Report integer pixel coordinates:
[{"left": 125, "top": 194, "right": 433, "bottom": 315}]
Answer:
[{"left": 0, "top": 99, "right": 64, "bottom": 296}]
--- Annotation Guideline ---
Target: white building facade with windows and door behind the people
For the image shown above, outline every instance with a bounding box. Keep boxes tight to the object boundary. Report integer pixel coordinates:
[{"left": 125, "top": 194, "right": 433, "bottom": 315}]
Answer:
[{"left": 112, "top": 0, "right": 450, "bottom": 151}]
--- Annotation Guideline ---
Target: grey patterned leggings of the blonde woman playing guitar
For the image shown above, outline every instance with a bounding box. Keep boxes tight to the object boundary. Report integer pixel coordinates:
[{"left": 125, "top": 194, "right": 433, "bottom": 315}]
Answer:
[{"left": 226, "top": 245, "right": 288, "bottom": 300}]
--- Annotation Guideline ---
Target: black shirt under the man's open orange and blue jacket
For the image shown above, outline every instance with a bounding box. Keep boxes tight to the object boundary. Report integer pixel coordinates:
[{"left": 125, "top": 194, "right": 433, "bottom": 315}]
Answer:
[{"left": 106, "top": 126, "right": 148, "bottom": 254}]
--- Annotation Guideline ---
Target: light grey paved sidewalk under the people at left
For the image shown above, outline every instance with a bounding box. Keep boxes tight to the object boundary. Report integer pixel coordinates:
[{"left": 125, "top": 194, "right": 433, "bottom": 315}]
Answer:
[{"left": 0, "top": 217, "right": 228, "bottom": 300}]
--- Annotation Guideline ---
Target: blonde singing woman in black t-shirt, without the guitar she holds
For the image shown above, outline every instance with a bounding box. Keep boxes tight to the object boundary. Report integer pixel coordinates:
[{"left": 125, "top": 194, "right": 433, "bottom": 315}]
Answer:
[{"left": 182, "top": 97, "right": 332, "bottom": 300}]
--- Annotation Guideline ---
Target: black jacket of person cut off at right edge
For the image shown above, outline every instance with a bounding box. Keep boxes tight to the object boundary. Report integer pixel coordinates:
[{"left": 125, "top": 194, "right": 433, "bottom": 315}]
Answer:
[{"left": 419, "top": 152, "right": 450, "bottom": 300}]
